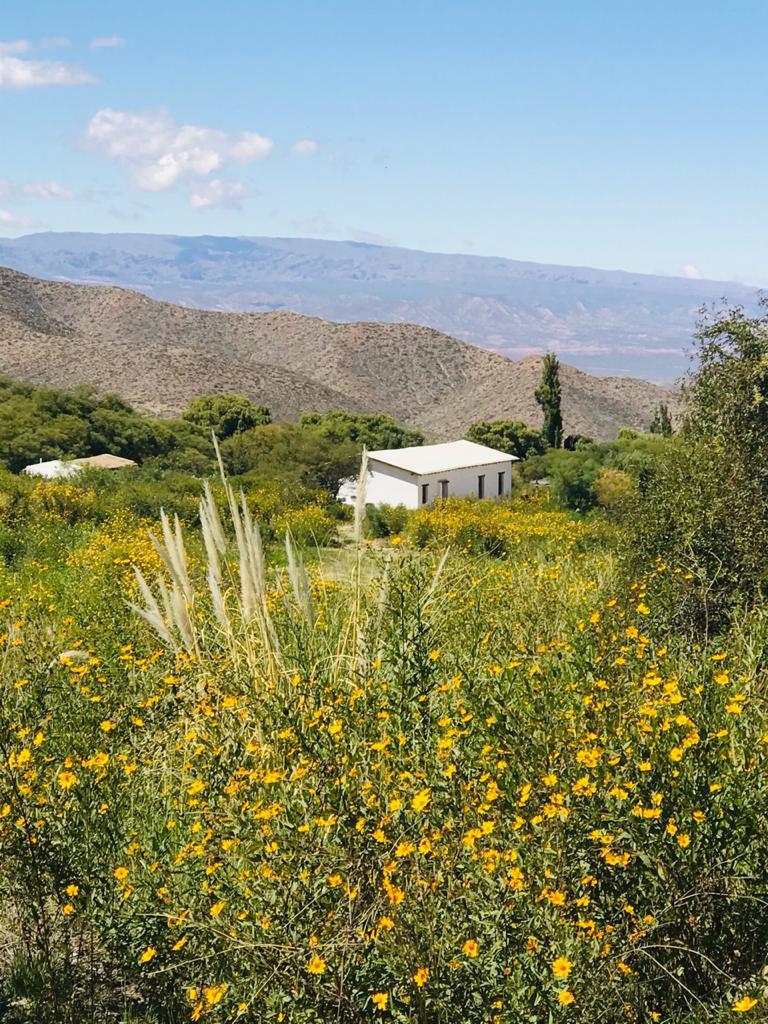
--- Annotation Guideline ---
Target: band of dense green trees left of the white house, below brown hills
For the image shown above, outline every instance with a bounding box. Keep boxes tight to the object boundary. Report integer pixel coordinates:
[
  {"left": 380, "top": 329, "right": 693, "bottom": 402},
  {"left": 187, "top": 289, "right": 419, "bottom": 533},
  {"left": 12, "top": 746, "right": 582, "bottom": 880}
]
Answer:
[{"left": 0, "top": 378, "right": 424, "bottom": 492}]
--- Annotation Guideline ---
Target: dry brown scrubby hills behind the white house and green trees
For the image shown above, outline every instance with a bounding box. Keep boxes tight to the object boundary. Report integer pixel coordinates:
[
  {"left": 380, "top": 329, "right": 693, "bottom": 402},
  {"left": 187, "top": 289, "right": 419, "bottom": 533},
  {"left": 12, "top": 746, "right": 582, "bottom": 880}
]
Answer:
[{"left": 0, "top": 268, "right": 673, "bottom": 439}]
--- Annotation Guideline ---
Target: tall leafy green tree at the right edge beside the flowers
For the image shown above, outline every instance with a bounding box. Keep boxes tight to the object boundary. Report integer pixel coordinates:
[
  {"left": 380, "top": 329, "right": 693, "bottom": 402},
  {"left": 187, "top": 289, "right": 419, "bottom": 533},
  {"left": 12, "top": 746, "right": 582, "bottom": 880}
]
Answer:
[{"left": 630, "top": 304, "right": 768, "bottom": 633}]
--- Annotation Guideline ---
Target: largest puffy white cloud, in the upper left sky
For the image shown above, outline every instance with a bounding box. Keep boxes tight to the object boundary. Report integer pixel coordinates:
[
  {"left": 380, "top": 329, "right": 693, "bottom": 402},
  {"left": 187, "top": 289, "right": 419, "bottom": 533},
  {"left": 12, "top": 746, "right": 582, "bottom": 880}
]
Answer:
[{"left": 85, "top": 108, "right": 272, "bottom": 203}]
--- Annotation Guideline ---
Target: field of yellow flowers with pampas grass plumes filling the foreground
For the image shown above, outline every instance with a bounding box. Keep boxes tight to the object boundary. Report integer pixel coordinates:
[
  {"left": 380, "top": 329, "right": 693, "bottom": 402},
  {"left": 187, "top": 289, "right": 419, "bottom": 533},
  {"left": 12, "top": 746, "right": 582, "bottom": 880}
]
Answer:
[{"left": 0, "top": 481, "right": 768, "bottom": 1024}]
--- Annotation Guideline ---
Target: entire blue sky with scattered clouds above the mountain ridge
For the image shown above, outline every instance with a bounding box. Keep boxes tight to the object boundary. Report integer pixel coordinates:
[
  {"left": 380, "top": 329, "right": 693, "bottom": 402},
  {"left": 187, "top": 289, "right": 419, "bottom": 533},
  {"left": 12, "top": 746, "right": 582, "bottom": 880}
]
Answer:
[{"left": 0, "top": 0, "right": 768, "bottom": 286}]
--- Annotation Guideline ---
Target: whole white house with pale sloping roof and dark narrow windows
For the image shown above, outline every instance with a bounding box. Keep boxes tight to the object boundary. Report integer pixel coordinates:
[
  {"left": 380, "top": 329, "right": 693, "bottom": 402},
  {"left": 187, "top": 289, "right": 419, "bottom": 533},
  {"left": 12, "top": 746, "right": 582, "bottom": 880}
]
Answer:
[{"left": 339, "top": 440, "right": 519, "bottom": 509}]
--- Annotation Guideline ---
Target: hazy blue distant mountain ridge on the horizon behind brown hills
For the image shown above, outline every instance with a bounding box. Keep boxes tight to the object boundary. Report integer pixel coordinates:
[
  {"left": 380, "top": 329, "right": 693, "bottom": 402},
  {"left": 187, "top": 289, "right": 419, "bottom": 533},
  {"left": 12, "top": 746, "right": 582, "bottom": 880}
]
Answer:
[{"left": 0, "top": 232, "right": 757, "bottom": 382}]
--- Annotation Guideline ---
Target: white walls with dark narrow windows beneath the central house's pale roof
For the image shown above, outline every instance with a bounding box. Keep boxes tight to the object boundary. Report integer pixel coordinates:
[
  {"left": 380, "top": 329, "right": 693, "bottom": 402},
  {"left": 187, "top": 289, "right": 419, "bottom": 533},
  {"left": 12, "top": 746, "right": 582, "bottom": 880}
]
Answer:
[{"left": 366, "top": 459, "right": 513, "bottom": 509}]
